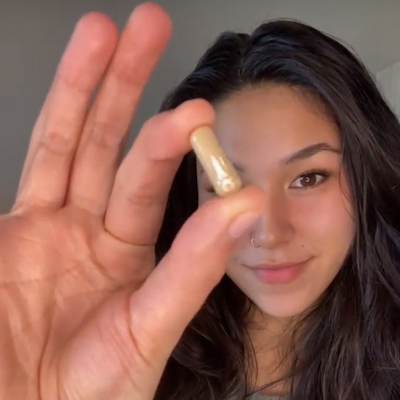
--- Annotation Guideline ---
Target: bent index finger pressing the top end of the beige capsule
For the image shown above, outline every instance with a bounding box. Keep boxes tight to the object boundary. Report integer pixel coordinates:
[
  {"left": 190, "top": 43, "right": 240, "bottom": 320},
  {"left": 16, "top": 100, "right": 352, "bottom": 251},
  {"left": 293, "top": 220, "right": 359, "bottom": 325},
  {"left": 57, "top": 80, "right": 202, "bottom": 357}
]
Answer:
[{"left": 104, "top": 99, "right": 215, "bottom": 245}]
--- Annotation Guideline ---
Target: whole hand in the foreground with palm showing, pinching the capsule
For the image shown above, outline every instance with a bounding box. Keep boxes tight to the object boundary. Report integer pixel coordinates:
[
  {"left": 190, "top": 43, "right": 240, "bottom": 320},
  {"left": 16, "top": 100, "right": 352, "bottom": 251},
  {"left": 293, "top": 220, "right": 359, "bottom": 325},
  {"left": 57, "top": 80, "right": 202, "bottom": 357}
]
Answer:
[{"left": 0, "top": 4, "right": 262, "bottom": 400}]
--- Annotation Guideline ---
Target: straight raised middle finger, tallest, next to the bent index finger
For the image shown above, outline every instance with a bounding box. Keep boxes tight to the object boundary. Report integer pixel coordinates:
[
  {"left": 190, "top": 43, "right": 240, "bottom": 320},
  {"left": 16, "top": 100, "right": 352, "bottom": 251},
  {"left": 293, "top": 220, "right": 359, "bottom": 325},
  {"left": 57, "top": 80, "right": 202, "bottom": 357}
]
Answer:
[{"left": 67, "top": 4, "right": 171, "bottom": 215}]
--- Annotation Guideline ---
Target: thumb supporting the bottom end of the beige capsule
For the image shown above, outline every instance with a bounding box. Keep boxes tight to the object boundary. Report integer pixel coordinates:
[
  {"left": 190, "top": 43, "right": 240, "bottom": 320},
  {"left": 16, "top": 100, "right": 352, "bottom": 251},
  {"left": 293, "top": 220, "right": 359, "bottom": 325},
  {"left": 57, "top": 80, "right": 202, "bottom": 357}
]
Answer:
[{"left": 130, "top": 187, "right": 265, "bottom": 400}]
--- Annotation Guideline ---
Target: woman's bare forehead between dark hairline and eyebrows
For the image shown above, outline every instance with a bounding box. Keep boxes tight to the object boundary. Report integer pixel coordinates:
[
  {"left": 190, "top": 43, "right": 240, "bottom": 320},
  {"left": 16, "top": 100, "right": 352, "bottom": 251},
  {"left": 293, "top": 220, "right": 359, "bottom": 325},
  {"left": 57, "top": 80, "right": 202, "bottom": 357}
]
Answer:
[{"left": 211, "top": 85, "right": 339, "bottom": 164}]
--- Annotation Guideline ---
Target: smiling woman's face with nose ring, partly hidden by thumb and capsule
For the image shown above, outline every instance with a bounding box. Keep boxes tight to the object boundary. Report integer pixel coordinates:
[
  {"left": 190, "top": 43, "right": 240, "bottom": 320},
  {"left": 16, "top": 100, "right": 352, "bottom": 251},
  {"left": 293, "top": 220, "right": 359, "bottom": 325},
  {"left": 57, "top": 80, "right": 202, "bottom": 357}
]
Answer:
[{"left": 197, "top": 85, "right": 355, "bottom": 318}]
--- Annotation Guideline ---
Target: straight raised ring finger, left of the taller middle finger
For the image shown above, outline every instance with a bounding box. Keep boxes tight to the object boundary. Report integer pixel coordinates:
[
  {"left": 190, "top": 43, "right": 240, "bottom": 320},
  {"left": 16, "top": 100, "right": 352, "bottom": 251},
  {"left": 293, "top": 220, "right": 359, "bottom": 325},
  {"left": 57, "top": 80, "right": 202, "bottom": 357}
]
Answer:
[{"left": 14, "top": 13, "right": 117, "bottom": 210}]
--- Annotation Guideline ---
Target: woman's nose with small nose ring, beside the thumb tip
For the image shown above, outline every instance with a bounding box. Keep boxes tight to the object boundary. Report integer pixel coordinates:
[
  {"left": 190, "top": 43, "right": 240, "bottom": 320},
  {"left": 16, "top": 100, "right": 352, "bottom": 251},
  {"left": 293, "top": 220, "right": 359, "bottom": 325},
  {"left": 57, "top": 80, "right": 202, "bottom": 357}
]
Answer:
[{"left": 251, "top": 192, "right": 294, "bottom": 249}]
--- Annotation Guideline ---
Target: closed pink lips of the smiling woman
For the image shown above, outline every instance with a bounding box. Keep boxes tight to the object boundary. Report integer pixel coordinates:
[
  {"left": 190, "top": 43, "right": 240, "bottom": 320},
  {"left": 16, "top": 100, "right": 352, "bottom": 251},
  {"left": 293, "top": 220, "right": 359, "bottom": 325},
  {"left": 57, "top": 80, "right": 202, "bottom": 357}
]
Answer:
[{"left": 248, "top": 260, "right": 309, "bottom": 285}]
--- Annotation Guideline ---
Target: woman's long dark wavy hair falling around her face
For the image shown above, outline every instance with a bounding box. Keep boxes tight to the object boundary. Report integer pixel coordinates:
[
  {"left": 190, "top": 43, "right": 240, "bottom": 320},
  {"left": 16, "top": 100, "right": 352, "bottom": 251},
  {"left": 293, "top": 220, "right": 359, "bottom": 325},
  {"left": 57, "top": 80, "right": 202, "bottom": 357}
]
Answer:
[{"left": 156, "top": 20, "right": 400, "bottom": 400}]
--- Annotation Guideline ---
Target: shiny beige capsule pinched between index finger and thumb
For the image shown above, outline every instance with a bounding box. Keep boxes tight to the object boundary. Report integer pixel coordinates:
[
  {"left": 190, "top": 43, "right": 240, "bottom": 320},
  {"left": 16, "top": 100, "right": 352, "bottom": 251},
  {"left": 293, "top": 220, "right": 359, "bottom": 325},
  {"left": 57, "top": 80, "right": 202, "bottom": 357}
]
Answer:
[{"left": 190, "top": 126, "right": 242, "bottom": 196}]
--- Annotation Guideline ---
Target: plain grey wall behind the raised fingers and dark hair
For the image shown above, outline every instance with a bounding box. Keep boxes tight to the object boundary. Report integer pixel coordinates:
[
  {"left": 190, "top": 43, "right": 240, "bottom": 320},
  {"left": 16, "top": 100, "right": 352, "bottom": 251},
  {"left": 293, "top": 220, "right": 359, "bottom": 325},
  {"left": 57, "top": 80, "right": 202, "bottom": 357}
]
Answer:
[{"left": 0, "top": 0, "right": 400, "bottom": 213}]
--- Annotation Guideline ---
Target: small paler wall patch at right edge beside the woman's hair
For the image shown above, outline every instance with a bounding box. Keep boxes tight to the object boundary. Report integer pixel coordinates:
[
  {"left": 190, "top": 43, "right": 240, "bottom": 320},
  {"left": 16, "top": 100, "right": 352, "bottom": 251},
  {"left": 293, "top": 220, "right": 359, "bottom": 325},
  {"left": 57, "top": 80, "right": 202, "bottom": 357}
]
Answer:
[{"left": 376, "top": 62, "right": 400, "bottom": 119}]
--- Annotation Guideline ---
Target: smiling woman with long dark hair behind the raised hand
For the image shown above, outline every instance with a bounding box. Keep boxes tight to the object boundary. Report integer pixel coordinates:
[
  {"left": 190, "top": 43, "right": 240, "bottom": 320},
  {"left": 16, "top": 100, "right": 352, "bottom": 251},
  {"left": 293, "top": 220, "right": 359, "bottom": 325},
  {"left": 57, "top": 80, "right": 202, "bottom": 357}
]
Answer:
[{"left": 156, "top": 21, "right": 400, "bottom": 400}]
